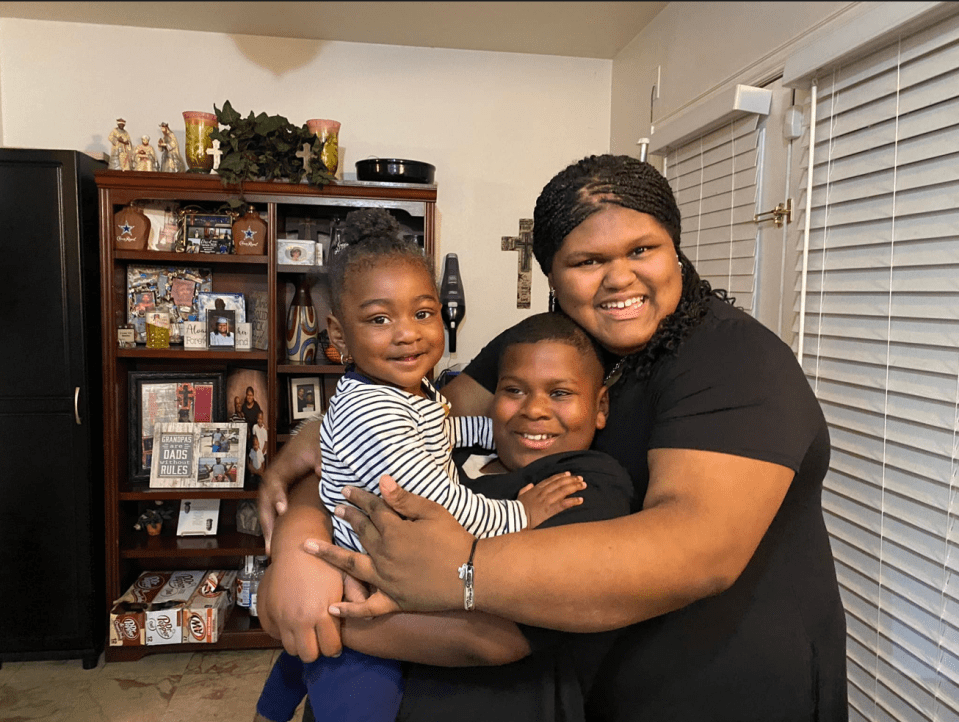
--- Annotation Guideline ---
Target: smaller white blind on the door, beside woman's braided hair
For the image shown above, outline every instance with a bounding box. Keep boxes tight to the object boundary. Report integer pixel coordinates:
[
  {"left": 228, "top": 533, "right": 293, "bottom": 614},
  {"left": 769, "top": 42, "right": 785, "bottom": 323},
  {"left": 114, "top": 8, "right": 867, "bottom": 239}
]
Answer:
[{"left": 664, "top": 115, "right": 765, "bottom": 314}]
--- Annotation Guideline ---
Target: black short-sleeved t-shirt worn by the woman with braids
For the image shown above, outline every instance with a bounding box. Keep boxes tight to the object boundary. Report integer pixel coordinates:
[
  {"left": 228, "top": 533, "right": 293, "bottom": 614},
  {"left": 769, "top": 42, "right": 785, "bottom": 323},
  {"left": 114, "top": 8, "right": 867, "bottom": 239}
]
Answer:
[{"left": 464, "top": 298, "right": 848, "bottom": 722}]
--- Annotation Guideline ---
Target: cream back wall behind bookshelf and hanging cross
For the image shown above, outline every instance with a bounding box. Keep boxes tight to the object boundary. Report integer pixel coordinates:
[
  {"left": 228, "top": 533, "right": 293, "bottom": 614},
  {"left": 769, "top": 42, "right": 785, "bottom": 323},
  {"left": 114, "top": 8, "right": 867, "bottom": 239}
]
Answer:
[{"left": 0, "top": 19, "right": 612, "bottom": 370}]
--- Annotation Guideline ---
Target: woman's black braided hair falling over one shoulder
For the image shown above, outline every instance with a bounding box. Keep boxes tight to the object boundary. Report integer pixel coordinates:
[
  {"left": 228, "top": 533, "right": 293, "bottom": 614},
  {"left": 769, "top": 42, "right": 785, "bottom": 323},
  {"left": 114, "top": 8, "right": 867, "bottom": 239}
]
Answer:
[{"left": 533, "top": 155, "right": 735, "bottom": 386}]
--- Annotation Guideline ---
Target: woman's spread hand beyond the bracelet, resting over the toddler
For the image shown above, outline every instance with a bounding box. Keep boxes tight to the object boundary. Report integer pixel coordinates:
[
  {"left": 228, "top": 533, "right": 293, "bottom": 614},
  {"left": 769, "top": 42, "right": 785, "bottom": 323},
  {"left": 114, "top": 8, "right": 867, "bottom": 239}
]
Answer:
[{"left": 304, "top": 476, "right": 473, "bottom": 617}]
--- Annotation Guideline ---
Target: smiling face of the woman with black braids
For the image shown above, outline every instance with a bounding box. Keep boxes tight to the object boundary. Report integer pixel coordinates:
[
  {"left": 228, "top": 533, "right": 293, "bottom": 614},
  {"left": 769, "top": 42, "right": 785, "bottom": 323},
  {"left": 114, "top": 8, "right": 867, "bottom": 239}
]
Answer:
[{"left": 548, "top": 205, "right": 683, "bottom": 356}]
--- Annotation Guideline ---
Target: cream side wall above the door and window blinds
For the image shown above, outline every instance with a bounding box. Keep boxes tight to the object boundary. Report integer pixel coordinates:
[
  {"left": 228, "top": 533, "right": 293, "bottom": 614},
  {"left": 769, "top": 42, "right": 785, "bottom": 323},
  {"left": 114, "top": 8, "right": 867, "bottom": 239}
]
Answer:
[{"left": 610, "top": 2, "right": 852, "bottom": 157}]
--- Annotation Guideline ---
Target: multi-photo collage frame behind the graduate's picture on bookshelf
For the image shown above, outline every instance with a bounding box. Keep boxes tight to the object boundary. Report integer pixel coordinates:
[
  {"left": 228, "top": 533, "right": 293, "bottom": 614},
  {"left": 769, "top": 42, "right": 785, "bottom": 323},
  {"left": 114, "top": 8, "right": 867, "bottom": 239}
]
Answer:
[{"left": 127, "top": 265, "right": 213, "bottom": 343}]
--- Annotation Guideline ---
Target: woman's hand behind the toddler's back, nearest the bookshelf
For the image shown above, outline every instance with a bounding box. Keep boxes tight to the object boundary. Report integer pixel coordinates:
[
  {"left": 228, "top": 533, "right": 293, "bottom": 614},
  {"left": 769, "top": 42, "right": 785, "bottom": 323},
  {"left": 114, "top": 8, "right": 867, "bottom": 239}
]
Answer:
[{"left": 257, "top": 420, "right": 321, "bottom": 554}]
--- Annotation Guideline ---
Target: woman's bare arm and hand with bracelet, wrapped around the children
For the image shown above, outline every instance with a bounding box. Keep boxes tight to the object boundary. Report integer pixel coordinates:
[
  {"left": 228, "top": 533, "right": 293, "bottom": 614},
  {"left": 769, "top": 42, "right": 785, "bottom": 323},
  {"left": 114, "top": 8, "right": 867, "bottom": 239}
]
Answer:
[{"left": 308, "top": 449, "right": 793, "bottom": 632}]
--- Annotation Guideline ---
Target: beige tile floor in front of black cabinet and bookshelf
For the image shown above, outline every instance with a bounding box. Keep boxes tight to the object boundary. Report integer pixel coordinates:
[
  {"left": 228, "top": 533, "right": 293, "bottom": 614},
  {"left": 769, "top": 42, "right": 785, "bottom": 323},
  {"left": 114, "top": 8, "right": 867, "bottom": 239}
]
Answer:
[{"left": 0, "top": 649, "right": 303, "bottom": 722}]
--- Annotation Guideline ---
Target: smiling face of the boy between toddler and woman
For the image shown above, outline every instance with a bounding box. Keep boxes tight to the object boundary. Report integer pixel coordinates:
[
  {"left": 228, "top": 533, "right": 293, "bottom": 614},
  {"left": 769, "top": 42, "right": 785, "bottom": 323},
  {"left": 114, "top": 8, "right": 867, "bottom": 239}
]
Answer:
[{"left": 490, "top": 341, "right": 609, "bottom": 470}]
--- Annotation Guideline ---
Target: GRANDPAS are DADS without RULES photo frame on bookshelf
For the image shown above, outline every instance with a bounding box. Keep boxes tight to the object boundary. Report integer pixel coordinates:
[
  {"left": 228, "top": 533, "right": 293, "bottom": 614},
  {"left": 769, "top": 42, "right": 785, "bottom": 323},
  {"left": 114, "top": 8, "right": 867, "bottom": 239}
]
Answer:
[{"left": 150, "top": 421, "right": 247, "bottom": 489}]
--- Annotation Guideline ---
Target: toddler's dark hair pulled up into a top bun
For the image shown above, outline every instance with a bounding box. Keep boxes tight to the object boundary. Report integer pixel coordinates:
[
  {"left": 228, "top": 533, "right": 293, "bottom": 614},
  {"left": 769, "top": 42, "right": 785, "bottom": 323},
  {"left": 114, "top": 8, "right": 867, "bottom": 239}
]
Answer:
[{"left": 329, "top": 208, "right": 436, "bottom": 315}]
